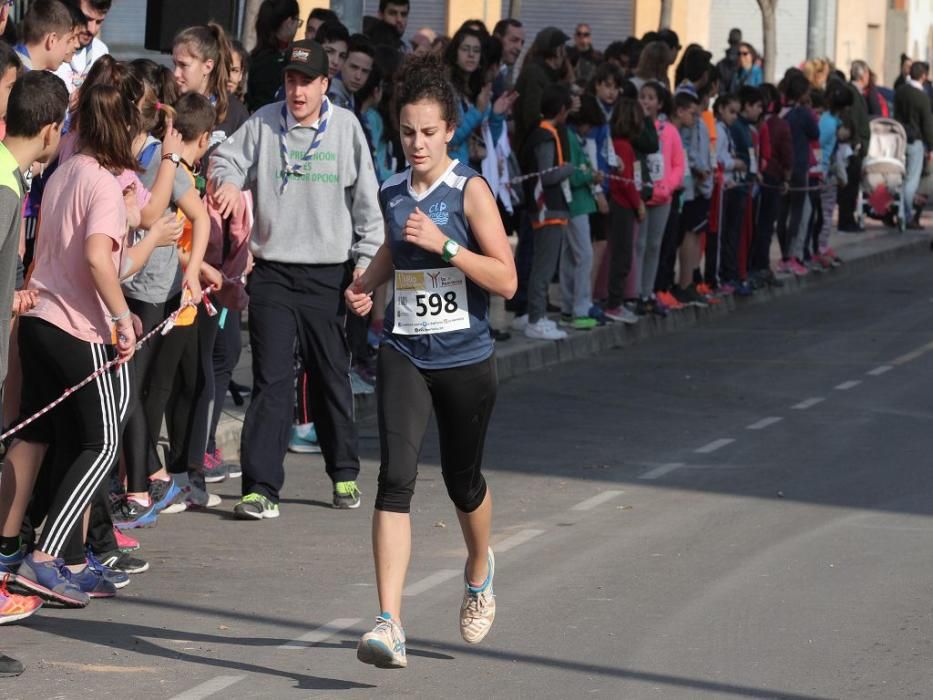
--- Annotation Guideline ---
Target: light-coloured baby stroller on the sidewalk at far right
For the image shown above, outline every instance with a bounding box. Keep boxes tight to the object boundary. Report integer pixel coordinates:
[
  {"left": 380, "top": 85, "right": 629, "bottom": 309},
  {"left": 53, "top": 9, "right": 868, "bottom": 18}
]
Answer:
[{"left": 856, "top": 118, "right": 907, "bottom": 231}]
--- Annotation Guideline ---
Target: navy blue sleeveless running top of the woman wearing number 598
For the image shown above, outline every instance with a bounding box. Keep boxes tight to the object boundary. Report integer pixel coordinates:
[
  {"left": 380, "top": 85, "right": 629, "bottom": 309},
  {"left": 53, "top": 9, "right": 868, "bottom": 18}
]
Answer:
[{"left": 379, "top": 160, "right": 493, "bottom": 369}]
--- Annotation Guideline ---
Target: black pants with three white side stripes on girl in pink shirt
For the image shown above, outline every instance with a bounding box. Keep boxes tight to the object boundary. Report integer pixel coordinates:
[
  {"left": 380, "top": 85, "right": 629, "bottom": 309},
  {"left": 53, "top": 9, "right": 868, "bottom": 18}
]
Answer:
[{"left": 19, "top": 317, "right": 130, "bottom": 557}]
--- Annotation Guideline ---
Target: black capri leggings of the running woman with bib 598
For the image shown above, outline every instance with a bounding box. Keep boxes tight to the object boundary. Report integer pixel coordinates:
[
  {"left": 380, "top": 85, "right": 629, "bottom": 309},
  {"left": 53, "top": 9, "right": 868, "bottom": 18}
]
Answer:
[{"left": 376, "top": 345, "right": 498, "bottom": 513}]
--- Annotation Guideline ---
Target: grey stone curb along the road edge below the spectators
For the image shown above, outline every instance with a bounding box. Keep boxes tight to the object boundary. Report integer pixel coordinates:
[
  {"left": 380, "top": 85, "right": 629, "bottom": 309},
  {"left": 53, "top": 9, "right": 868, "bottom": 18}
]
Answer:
[{"left": 217, "top": 233, "right": 933, "bottom": 457}]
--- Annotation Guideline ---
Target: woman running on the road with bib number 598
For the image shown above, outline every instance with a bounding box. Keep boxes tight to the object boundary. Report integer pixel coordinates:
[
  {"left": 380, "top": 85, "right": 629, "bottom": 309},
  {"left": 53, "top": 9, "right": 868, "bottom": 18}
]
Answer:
[{"left": 346, "top": 57, "right": 517, "bottom": 668}]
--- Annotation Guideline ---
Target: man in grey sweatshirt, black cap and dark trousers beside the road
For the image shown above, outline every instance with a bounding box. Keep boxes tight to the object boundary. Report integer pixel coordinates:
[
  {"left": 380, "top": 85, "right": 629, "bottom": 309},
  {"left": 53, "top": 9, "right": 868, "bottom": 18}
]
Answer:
[{"left": 209, "top": 40, "right": 385, "bottom": 520}]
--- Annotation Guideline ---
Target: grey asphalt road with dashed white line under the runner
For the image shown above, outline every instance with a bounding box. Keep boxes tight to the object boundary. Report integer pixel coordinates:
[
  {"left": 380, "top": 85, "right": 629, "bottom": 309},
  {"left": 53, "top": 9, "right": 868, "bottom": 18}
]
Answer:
[{"left": 0, "top": 256, "right": 933, "bottom": 700}]
